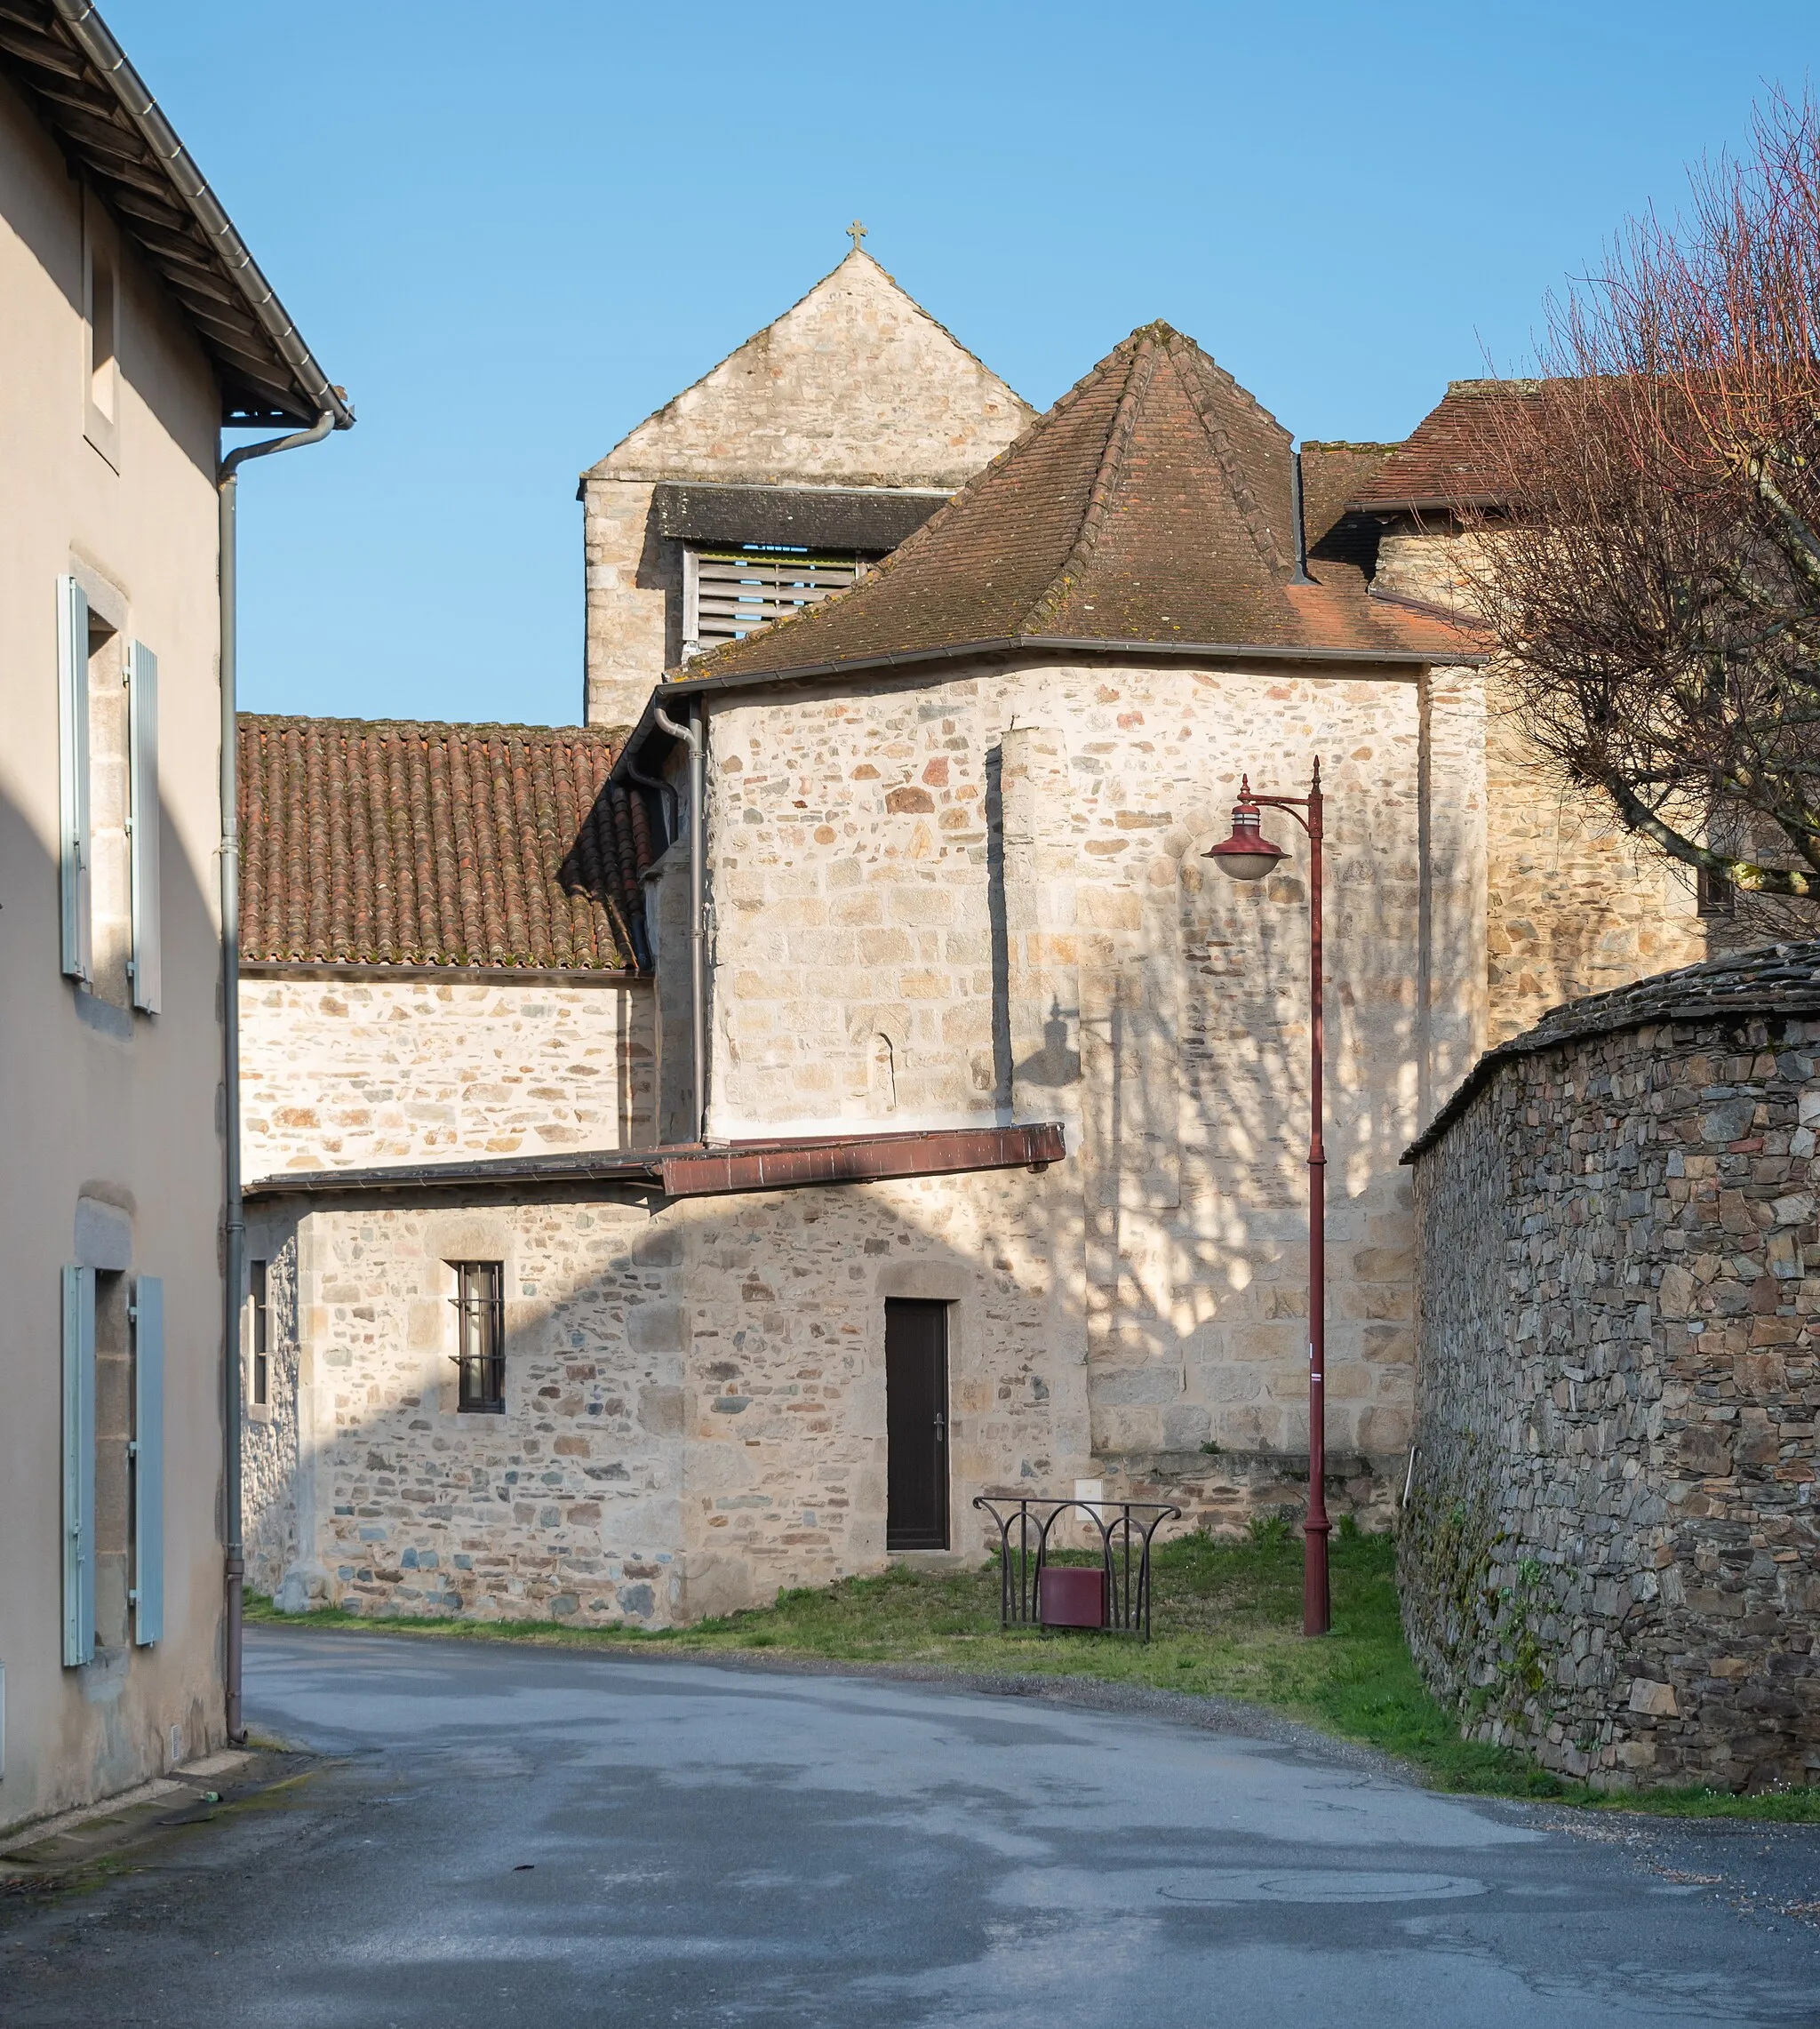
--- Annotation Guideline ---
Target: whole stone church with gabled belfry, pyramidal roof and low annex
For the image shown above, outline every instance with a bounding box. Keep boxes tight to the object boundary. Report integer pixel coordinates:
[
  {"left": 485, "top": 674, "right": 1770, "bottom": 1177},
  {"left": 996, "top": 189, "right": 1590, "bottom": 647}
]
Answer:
[{"left": 242, "top": 252, "right": 1706, "bottom": 1627}]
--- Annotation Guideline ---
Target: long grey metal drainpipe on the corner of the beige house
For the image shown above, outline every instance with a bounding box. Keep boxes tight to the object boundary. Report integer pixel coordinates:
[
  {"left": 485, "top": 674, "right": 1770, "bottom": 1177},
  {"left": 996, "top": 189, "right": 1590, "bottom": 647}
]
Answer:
[{"left": 217, "top": 410, "right": 335, "bottom": 1747}]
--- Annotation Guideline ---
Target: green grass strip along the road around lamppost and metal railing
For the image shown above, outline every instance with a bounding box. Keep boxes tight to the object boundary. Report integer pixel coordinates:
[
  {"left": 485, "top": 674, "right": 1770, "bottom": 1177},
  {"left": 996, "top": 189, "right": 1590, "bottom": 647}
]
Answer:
[{"left": 245, "top": 1522, "right": 1820, "bottom": 1824}]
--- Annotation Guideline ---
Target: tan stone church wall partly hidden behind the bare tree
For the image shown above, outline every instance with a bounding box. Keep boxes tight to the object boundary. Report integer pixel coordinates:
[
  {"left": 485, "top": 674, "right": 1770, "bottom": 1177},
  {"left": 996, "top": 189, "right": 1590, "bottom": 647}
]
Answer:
[{"left": 1374, "top": 517, "right": 1708, "bottom": 1042}]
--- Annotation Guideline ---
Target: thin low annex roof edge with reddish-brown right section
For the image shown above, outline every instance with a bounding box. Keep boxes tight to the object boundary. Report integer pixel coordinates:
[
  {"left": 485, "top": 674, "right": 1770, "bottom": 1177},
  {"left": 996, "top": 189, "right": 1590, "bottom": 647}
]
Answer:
[{"left": 245, "top": 1120, "right": 1067, "bottom": 1203}]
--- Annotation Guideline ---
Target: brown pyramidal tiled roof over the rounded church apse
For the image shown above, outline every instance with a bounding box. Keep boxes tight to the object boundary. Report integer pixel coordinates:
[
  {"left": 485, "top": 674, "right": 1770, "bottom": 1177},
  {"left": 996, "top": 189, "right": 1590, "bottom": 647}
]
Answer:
[{"left": 680, "top": 323, "right": 1473, "bottom": 678}]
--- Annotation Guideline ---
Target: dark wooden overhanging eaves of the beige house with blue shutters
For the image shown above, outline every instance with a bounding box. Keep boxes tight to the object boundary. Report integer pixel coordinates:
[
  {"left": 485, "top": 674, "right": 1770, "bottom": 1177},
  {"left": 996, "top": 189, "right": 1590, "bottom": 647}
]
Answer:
[{"left": 0, "top": 0, "right": 353, "bottom": 430}]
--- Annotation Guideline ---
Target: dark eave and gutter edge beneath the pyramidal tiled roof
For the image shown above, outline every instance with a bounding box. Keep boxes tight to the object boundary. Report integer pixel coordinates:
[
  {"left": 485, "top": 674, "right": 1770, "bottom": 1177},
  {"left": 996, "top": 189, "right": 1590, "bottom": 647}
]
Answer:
[{"left": 609, "top": 628, "right": 1491, "bottom": 783}]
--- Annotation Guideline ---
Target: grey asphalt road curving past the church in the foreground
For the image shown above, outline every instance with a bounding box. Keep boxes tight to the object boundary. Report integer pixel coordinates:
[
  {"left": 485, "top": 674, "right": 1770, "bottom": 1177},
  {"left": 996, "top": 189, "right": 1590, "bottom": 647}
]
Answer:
[{"left": 0, "top": 1632, "right": 1820, "bottom": 2029}]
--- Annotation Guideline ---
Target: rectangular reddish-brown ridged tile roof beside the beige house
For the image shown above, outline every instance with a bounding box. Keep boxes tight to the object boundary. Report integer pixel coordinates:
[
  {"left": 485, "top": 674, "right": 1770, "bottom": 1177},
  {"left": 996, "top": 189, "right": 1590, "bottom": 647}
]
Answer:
[{"left": 239, "top": 712, "right": 651, "bottom": 972}]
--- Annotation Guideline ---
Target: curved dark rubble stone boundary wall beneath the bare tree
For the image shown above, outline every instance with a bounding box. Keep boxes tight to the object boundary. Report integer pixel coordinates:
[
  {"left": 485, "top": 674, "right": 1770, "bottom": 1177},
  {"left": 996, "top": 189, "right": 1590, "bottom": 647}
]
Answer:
[{"left": 1402, "top": 1018, "right": 1820, "bottom": 1787}]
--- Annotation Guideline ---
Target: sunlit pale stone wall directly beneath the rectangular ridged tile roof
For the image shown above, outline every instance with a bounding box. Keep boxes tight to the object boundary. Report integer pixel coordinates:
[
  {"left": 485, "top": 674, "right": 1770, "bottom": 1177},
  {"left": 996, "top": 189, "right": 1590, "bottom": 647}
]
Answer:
[{"left": 239, "top": 976, "right": 653, "bottom": 1178}]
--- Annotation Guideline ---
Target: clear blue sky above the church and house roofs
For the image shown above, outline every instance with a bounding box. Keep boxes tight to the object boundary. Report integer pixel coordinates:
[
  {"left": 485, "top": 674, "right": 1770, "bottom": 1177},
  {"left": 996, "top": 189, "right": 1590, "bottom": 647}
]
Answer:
[{"left": 103, "top": 0, "right": 1820, "bottom": 723}]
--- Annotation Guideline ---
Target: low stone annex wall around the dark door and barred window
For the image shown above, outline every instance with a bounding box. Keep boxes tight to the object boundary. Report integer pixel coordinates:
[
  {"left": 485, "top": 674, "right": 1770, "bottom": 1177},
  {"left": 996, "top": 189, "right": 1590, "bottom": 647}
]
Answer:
[{"left": 248, "top": 1173, "right": 1091, "bottom": 1626}]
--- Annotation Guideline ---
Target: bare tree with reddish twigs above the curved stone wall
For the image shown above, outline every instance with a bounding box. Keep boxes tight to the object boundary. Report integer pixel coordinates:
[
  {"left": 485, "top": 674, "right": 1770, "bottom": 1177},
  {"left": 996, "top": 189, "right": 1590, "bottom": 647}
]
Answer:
[{"left": 1467, "top": 100, "right": 1820, "bottom": 899}]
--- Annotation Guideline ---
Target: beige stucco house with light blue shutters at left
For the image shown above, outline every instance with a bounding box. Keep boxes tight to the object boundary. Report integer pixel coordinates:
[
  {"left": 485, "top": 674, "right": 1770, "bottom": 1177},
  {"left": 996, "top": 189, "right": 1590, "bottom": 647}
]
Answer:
[{"left": 0, "top": 0, "right": 349, "bottom": 1824}]
